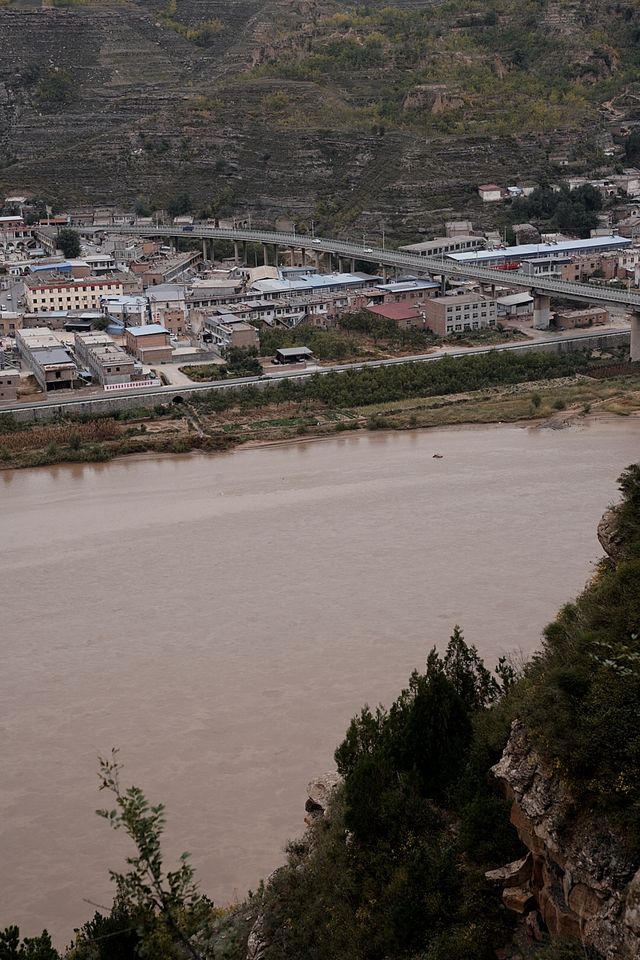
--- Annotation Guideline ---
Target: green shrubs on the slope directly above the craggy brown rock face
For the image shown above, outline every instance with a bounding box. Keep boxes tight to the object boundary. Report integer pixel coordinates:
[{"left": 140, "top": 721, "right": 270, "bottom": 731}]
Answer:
[{"left": 520, "top": 465, "right": 640, "bottom": 850}]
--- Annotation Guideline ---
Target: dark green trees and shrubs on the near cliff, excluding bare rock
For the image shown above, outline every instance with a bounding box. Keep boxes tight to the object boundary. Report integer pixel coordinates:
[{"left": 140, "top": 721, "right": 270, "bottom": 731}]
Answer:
[{"left": 0, "top": 464, "right": 640, "bottom": 960}]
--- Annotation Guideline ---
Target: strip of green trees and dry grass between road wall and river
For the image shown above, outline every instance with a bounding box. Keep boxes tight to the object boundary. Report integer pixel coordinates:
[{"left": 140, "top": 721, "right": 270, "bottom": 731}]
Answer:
[{"left": 0, "top": 352, "right": 640, "bottom": 468}]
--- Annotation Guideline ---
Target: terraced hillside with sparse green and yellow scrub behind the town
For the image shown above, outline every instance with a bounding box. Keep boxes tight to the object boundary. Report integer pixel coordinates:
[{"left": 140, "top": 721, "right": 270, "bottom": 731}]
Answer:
[{"left": 0, "top": 0, "right": 640, "bottom": 234}]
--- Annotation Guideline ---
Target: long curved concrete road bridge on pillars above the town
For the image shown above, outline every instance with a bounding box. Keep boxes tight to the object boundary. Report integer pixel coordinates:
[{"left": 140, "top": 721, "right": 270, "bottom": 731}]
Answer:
[{"left": 78, "top": 224, "right": 640, "bottom": 360}]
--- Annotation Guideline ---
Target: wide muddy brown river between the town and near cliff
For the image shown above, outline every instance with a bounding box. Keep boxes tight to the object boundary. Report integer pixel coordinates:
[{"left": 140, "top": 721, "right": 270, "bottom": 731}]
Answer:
[{"left": 0, "top": 418, "right": 640, "bottom": 945}]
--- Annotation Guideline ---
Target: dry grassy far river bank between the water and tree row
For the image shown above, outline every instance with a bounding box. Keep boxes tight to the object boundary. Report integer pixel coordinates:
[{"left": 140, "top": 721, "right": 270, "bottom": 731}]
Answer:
[{"left": 0, "top": 374, "right": 640, "bottom": 469}]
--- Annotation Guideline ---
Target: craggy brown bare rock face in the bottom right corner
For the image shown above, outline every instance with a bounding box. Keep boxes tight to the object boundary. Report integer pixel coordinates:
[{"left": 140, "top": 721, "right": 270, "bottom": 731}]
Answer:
[{"left": 487, "top": 721, "right": 640, "bottom": 960}]
